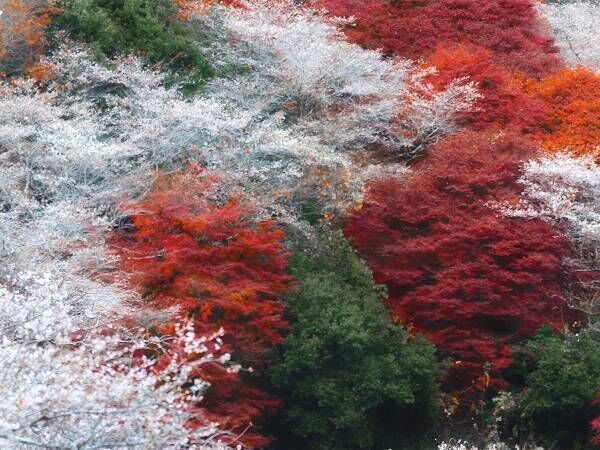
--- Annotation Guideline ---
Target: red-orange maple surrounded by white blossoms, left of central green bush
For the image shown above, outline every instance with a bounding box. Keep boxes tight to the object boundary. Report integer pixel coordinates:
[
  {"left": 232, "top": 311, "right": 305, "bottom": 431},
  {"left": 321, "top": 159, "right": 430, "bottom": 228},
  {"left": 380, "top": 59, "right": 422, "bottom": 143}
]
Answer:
[{"left": 117, "top": 177, "right": 289, "bottom": 446}]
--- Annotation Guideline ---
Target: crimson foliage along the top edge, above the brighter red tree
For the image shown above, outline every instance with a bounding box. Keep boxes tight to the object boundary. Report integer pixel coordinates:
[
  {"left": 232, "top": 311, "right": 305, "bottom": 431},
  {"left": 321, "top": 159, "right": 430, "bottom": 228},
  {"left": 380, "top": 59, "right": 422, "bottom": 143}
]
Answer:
[{"left": 317, "top": 0, "right": 561, "bottom": 77}]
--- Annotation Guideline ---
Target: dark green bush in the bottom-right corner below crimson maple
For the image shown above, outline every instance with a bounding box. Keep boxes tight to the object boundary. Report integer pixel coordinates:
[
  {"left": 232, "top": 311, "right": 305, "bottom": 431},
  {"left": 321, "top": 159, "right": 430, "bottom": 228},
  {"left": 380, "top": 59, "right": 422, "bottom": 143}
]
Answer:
[{"left": 506, "top": 328, "right": 600, "bottom": 449}]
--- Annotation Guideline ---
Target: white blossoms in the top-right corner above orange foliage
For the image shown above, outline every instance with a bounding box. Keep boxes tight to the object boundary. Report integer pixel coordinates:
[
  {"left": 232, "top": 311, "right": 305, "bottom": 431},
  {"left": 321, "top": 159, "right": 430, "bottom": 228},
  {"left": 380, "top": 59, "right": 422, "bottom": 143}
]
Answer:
[{"left": 537, "top": 0, "right": 600, "bottom": 72}]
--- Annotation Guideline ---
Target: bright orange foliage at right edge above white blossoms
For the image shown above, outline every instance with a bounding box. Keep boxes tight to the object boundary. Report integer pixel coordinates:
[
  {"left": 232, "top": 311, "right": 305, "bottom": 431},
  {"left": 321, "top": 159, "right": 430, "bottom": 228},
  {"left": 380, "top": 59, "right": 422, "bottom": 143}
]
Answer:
[{"left": 529, "top": 67, "right": 600, "bottom": 162}]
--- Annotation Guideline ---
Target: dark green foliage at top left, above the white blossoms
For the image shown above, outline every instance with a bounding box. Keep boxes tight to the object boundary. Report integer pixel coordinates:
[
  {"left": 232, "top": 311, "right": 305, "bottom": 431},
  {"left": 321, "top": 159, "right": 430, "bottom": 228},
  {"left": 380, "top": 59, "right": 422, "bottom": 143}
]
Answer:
[{"left": 54, "top": 0, "right": 212, "bottom": 89}]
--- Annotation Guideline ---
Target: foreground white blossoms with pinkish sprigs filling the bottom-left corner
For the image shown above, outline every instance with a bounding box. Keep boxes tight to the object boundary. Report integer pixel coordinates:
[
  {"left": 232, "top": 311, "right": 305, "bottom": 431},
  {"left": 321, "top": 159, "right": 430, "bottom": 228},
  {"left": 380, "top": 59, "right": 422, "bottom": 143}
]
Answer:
[{"left": 0, "top": 312, "right": 233, "bottom": 450}]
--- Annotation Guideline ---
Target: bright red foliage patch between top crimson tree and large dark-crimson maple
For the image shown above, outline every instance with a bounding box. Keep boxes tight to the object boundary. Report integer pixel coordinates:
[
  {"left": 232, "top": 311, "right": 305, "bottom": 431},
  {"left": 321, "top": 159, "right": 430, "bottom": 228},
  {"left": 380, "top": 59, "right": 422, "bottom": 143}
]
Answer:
[{"left": 427, "top": 44, "right": 544, "bottom": 133}]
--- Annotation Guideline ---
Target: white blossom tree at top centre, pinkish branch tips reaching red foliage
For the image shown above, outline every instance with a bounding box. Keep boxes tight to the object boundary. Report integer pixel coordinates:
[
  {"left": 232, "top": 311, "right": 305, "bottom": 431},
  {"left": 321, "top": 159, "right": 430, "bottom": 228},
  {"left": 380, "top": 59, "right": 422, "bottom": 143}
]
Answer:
[{"left": 206, "top": 0, "right": 478, "bottom": 154}]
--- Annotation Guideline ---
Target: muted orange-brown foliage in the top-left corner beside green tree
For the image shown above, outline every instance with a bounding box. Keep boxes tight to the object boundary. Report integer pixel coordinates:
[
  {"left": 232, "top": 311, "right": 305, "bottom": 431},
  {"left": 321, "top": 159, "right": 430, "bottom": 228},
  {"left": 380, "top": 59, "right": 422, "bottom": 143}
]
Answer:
[{"left": 0, "top": 0, "right": 54, "bottom": 75}]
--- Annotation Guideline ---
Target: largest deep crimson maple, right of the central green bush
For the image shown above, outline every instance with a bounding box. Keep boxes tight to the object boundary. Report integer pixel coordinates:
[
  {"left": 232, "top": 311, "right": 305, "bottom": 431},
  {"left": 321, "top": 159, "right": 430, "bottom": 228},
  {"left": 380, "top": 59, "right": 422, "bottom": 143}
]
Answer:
[{"left": 345, "top": 133, "right": 568, "bottom": 400}]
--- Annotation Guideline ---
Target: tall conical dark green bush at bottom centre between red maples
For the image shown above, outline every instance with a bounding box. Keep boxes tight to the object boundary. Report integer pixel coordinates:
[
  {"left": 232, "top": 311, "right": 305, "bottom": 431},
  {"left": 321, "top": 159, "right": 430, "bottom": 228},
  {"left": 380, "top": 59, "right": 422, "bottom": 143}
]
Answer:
[{"left": 272, "top": 233, "right": 441, "bottom": 450}]
